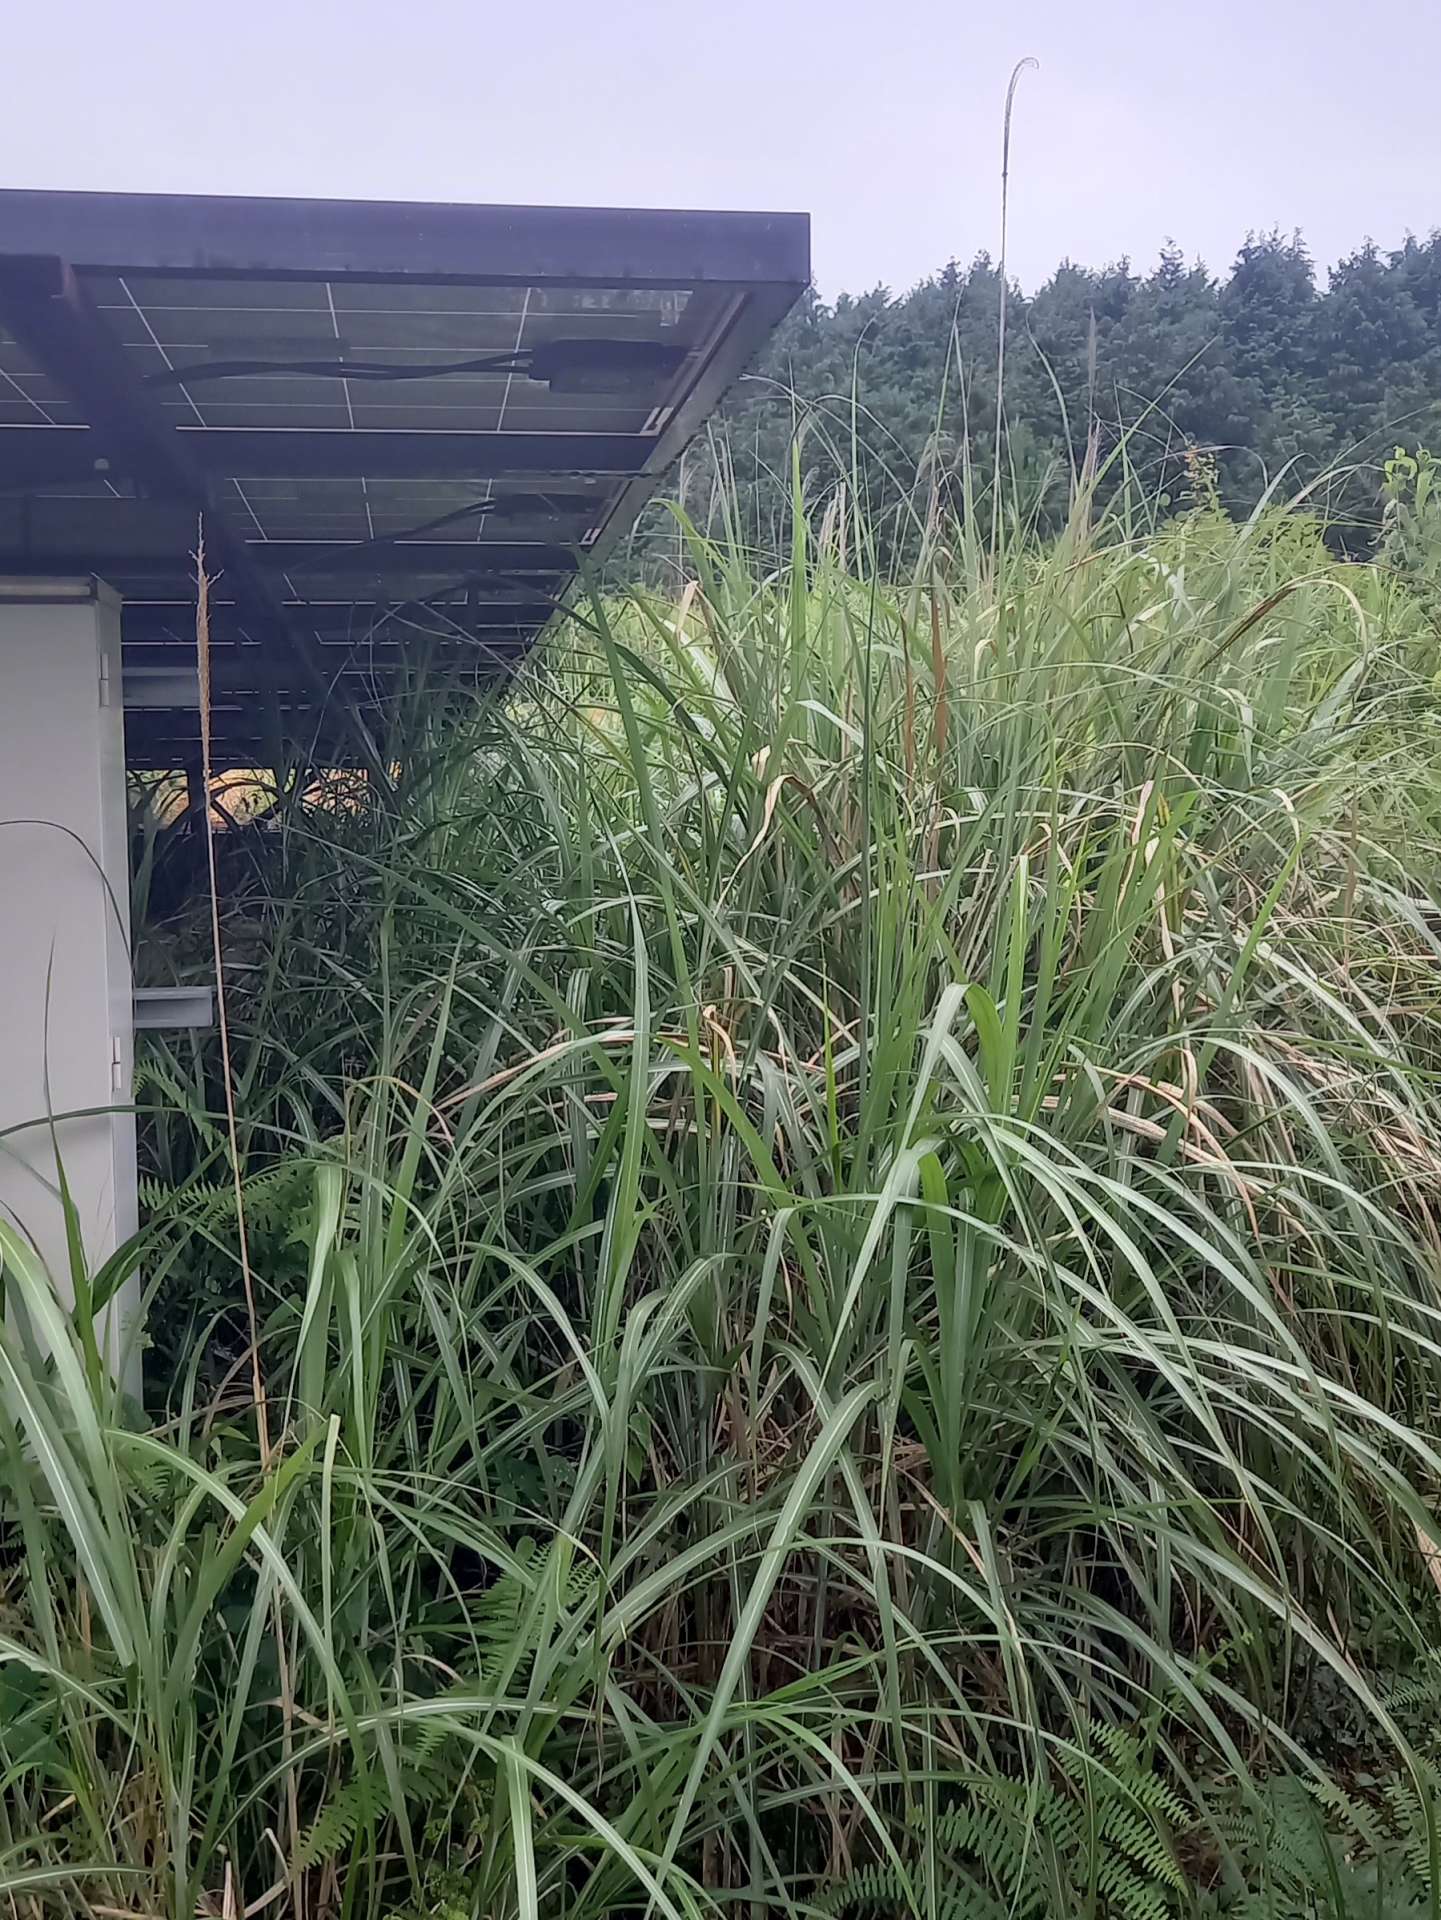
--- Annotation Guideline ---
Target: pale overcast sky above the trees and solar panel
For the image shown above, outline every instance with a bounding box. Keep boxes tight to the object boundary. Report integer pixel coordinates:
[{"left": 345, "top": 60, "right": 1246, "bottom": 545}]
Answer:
[{"left": 0, "top": 0, "right": 1441, "bottom": 296}]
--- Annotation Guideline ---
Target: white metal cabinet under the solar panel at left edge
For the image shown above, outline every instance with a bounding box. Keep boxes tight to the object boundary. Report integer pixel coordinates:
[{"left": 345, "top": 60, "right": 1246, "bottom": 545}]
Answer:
[{"left": 0, "top": 578, "right": 140, "bottom": 1386}]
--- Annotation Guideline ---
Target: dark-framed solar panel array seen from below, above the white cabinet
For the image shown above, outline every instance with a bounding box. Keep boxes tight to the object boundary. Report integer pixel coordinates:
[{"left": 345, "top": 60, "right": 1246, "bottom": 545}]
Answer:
[{"left": 0, "top": 192, "right": 810, "bottom": 766}]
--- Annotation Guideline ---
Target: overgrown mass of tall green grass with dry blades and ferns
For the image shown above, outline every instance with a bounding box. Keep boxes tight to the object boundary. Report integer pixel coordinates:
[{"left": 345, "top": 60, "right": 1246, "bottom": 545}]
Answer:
[{"left": 0, "top": 472, "right": 1441, "bottom": 1920}]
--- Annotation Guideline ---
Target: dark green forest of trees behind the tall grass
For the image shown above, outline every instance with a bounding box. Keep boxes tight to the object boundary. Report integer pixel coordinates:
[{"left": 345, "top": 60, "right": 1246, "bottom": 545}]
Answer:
[{"left": 643, "top": 232, "right": 1441, "bottom": 566}]
